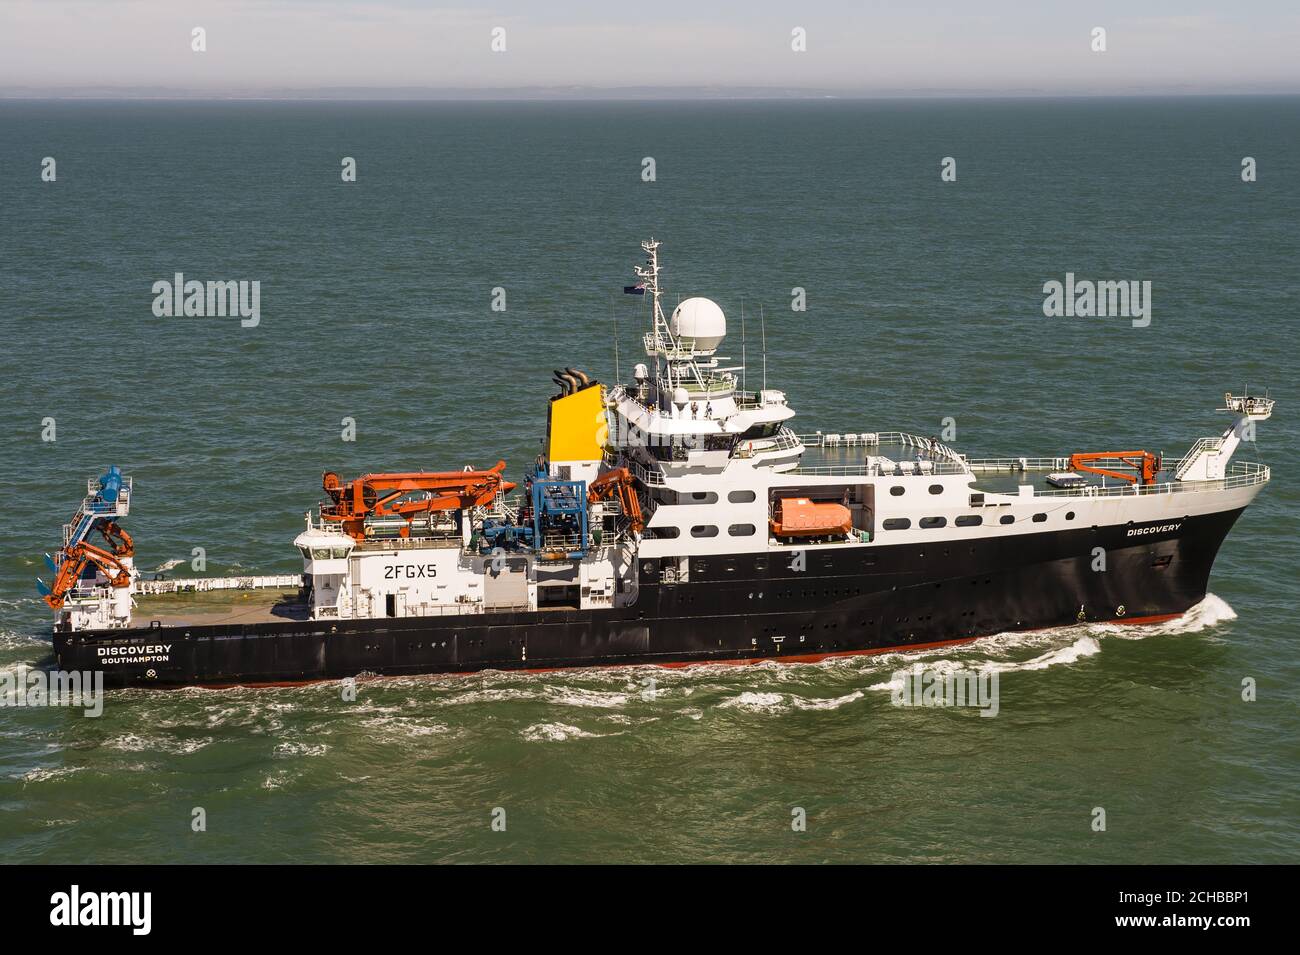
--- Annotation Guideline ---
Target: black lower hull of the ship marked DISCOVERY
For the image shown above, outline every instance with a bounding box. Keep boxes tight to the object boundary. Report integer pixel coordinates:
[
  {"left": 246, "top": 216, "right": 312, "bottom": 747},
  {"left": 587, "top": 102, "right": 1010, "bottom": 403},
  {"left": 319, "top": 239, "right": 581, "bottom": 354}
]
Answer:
[{"left": 55, "top": 508, "right": 1244, "bottom": 686}]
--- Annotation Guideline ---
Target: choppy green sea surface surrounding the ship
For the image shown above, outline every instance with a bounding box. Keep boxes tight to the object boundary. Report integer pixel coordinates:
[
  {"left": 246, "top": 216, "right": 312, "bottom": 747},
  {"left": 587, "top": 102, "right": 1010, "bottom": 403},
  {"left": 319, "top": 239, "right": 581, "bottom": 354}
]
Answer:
[{"left": 0, "top": 97, "right": 1300, "bottom": 863}]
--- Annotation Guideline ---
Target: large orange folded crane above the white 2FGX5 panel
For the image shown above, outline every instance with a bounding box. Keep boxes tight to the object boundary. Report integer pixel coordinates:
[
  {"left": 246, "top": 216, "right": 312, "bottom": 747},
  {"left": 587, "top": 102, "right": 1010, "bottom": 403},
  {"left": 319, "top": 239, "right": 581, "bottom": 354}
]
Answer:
[{"left": 321, "top": 461, "right": 515, "bottom": 541}]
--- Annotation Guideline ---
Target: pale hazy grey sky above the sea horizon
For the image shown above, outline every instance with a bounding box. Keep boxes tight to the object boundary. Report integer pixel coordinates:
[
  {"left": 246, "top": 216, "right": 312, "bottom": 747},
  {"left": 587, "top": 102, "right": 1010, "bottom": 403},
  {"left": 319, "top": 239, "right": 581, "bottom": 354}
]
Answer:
[{"left": 0, "top": 0, "right": 1300, "bottom": 95}]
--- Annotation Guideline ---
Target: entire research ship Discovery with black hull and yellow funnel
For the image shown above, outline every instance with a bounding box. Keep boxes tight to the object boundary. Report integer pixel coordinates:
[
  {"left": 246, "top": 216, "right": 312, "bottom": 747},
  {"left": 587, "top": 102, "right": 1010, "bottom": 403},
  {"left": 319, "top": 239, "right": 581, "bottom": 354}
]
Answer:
[{"left": 38, "top": 239, "right": 1274, "bottom": 686}]
